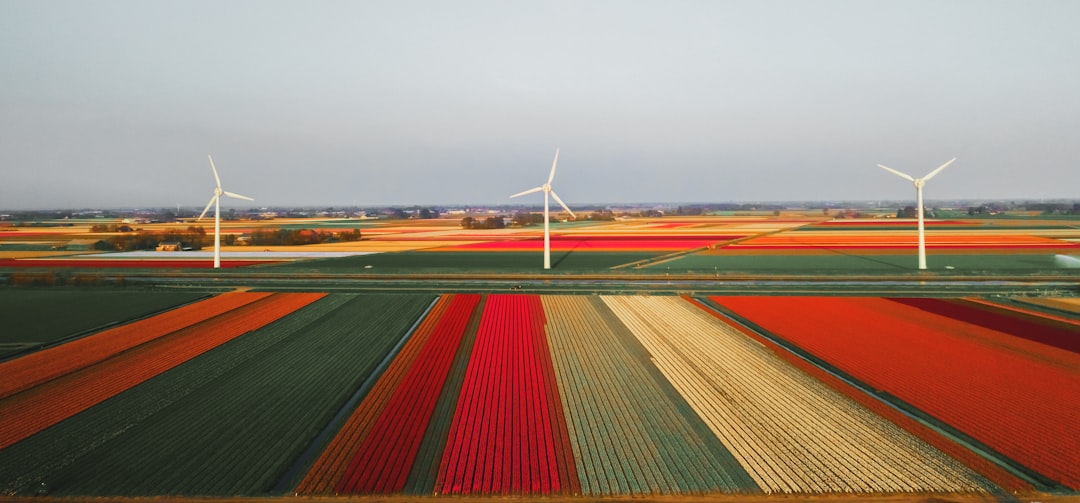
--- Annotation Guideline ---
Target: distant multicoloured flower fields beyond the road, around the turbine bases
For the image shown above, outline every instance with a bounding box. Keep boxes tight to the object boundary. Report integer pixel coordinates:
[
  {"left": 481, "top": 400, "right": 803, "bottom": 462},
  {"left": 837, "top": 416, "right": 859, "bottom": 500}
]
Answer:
[{"left": 0, "top": 215, "right": 1080, "bottom": 275}]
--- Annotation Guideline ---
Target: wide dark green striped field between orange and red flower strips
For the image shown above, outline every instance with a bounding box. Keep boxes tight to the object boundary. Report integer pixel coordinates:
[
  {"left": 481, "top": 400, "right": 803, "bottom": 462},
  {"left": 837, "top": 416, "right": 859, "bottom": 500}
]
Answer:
[{"left": 0, "top": 295, "right": 432, "bottom": 497}]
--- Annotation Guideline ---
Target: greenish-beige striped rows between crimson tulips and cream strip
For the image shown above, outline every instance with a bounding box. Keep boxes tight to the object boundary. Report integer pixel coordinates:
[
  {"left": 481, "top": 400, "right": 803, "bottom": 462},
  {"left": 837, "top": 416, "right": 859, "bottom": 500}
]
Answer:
[{"left": 542, "top": 296, "right": 757, "bottom": 495}]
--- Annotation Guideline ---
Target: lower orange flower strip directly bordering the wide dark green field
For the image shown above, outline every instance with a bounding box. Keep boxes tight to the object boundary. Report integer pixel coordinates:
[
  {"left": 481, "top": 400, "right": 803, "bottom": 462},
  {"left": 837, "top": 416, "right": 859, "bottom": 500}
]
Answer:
[{"left": 0, "top": 294, "right": 324, "bottom": 449}]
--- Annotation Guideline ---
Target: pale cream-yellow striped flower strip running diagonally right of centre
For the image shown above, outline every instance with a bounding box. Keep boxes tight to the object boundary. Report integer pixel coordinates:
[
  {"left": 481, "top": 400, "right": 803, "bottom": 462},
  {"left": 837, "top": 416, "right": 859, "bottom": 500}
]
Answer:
[{"left": 604, "top": 297, "right": 989, "bottom": 493}]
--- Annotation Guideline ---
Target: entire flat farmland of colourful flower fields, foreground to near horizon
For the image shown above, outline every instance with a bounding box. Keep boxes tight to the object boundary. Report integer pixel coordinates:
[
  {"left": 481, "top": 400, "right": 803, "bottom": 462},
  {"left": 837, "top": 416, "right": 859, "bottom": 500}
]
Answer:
[{"left": 0, "top": 216, "right": 1080, "bottom": 499}]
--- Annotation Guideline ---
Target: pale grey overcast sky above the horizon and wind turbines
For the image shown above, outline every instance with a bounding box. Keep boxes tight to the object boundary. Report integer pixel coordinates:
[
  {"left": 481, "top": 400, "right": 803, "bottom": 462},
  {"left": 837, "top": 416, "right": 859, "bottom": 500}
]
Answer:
[{"left": 0, "top": 0, "right": 1080, "bottom": 209}]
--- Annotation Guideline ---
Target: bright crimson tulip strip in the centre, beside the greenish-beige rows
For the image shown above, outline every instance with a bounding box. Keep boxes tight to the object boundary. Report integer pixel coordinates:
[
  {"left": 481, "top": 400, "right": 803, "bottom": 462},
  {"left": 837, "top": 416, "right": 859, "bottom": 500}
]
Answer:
[{"left": 436, "top": 295, "right": 580, "bottom": 494}]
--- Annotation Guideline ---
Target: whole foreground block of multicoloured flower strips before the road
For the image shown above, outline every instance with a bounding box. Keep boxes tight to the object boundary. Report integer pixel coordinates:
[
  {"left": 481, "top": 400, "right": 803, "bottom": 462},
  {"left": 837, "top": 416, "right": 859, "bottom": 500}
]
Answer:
[{"left": 0, "top": 289, "right": 1080, "bottom": 498}]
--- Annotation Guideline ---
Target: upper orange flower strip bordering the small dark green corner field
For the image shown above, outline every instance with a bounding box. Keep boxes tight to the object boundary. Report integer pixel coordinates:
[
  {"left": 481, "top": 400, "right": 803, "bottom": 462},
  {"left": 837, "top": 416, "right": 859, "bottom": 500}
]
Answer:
[{"left": 0, "top": 293, "right": 270, "bottom": 398}]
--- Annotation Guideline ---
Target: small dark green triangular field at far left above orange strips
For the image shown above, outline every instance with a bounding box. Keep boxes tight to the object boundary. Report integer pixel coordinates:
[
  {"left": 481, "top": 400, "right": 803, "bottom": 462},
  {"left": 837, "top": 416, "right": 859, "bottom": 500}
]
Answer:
[{"left": 0, "top": 288, "right": 207, "bottom": 359}]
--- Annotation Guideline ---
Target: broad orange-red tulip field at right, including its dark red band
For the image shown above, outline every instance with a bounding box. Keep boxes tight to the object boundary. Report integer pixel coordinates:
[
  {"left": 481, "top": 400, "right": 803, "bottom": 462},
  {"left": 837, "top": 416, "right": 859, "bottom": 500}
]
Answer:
[{"left": 713, "top": 297, "right": 1080, "bottom": 489}]
